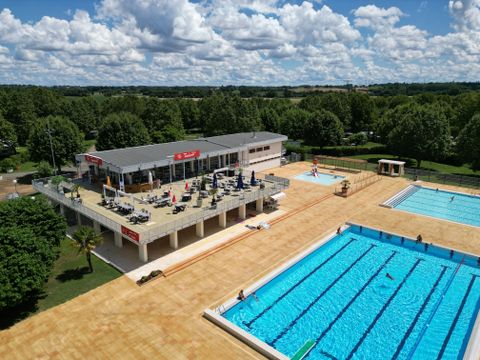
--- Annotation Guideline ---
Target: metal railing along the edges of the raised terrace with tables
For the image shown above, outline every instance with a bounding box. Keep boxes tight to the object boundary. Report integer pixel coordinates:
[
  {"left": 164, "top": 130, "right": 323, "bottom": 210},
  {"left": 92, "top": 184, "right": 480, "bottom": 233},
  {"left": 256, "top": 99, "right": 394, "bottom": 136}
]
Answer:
[{"left": 32, "top": 175, "right": 289, "bottom": 244}]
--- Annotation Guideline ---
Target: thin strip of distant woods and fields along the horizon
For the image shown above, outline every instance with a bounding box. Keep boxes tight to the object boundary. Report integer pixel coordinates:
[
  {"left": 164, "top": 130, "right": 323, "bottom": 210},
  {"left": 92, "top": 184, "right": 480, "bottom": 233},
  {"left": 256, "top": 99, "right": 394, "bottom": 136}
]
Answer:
[{"left": 0, "top": 82, "right": 480, "bottom": 98}]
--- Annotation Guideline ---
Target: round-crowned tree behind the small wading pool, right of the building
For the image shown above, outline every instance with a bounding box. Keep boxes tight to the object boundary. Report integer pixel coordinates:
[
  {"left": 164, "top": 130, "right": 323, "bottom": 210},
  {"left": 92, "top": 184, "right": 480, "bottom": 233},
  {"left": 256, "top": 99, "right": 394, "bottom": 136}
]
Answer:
[{"left": 303, "top": 110, "right": 343, "bottom": 147}]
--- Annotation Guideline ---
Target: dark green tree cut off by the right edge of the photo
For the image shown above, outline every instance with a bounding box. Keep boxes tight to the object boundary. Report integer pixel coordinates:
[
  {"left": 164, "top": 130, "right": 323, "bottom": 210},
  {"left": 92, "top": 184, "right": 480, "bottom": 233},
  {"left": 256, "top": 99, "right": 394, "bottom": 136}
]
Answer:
[{"left": 457, "top": 114, "right": 480, "bottom": 170}]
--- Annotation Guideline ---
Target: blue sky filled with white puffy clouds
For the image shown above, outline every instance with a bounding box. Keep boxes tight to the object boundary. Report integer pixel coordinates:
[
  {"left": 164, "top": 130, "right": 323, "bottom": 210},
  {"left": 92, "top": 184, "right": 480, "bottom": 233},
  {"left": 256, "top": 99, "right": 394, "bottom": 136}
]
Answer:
[{"left": 0, "top": 0, "right": 480, "bottom": 86}]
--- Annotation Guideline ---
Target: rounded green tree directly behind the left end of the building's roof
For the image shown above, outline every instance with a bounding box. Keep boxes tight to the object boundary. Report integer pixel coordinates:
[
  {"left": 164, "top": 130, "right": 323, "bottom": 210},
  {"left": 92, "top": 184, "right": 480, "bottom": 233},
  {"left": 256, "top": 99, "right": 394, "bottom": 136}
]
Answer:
[{"left": 95, "top": 112, "right": 150, "bottom": 150}]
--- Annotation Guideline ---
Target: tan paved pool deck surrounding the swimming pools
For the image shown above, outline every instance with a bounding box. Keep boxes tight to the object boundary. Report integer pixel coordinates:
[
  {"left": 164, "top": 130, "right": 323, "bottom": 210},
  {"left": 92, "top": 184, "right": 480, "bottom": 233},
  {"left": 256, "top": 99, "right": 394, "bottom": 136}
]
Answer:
[{"left": 0, "top": 163, "right": 480, "bottom": 359}]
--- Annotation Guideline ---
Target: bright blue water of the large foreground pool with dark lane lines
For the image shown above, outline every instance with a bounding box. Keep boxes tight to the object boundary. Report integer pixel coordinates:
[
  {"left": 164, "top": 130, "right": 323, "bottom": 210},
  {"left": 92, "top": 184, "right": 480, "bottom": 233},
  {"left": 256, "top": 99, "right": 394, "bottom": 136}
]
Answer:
[{"left": 223, "top": 226, "right": 480, "bottom": 360}]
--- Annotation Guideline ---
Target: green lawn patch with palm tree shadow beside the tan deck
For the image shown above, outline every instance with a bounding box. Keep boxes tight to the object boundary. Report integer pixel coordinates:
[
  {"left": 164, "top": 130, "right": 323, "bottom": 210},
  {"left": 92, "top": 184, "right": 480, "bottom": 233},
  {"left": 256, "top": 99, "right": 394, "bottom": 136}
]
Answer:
[{"left": 0, "top": 238, "right": 121, "bottom": 329}]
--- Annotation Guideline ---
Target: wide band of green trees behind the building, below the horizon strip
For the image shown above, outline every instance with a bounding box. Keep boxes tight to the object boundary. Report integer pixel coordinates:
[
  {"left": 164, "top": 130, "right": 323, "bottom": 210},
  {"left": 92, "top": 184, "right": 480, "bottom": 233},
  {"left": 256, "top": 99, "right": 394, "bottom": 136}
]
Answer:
[{"left": 0, "top": 88, "right": 480, "bottom": 172}]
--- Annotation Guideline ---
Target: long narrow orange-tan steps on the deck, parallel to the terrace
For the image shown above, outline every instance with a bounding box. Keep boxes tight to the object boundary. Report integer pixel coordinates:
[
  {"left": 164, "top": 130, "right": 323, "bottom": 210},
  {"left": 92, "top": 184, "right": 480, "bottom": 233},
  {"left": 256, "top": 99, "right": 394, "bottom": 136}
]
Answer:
[{"left": 162, "top": 194, "right": 333, "bottom": 277}]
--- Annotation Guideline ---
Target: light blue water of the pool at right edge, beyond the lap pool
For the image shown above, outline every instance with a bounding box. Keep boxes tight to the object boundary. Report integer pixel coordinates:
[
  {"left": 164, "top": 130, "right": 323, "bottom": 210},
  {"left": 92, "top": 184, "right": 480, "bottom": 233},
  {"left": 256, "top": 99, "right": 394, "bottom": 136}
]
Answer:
[{"left": 395, "top": 187, "right": 480, "bottom": 226}]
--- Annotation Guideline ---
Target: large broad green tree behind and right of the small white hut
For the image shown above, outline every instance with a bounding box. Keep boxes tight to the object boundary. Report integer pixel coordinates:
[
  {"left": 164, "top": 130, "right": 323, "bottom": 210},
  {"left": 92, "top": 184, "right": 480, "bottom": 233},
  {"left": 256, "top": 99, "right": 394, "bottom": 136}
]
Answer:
[{"left": 387, "top": 103, "right": 451, "bottom": 167}]
